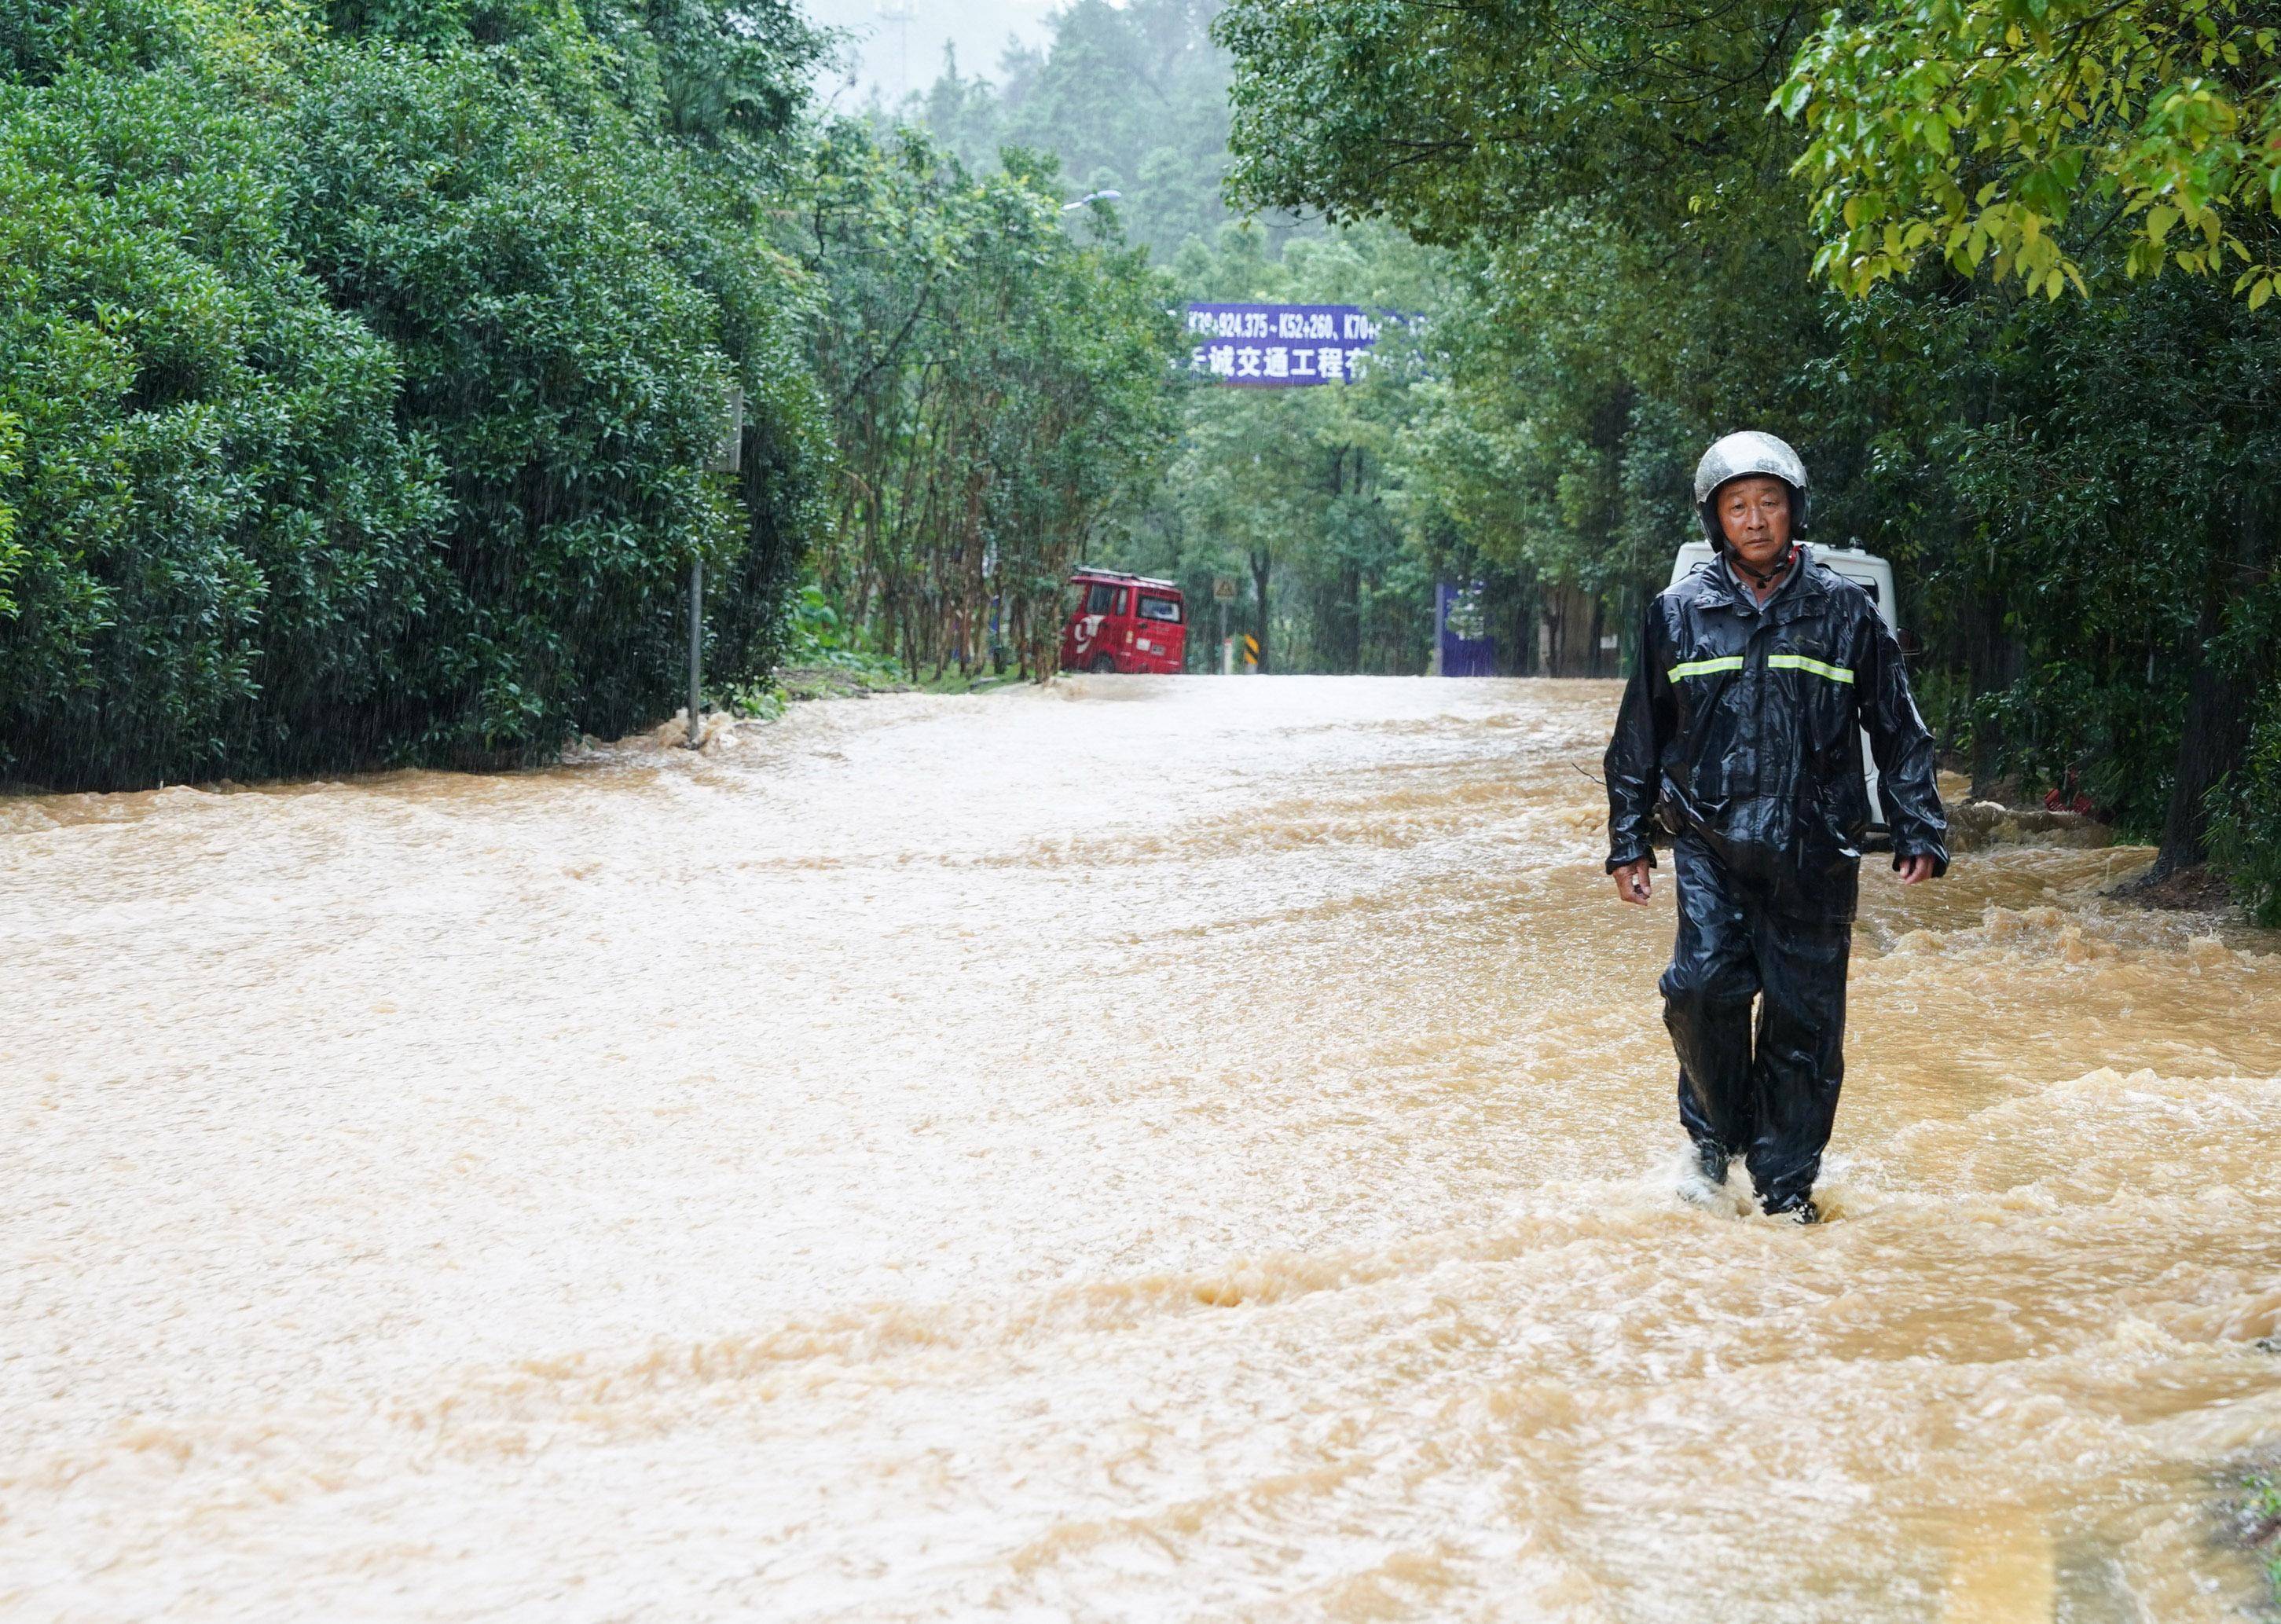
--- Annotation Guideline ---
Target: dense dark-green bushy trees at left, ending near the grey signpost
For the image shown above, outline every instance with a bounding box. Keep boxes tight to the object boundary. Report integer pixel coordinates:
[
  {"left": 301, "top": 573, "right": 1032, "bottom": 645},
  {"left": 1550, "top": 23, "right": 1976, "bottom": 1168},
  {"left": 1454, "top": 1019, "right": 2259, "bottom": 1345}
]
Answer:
[{"left": 0, "top": 0, "right": 834, "bottom": 785}]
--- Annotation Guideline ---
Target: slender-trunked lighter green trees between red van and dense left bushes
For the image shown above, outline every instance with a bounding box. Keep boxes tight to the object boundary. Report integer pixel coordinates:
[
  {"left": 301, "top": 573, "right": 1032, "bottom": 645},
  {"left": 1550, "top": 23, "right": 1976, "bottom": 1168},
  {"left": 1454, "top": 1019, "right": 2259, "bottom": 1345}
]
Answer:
[{"left": 796, "top": 121, "right": 1177, "bottom": 677}]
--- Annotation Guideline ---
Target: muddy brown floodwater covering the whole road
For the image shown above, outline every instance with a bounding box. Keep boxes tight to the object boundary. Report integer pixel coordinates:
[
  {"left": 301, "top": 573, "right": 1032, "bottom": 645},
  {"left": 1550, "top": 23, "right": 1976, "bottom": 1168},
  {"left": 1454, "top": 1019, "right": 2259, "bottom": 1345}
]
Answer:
[{"left": 13, "top": 677, "right": 2281, "bottom": 1624}]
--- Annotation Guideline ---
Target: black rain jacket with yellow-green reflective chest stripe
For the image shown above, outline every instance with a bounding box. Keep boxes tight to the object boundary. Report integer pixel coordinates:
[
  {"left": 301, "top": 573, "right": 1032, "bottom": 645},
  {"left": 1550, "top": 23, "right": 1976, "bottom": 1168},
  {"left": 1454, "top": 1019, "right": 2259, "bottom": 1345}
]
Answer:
[{"left": 1606, "top": 550, "right": 1948, "bottom": 874}]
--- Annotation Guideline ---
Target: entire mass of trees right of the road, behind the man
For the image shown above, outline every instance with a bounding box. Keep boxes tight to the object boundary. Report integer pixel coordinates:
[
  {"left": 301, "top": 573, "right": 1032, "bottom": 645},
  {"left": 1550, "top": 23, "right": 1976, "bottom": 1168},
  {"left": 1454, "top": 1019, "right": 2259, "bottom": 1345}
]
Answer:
[{"left": 1220, "top": 0, "right": 2281, "bottom": 907}]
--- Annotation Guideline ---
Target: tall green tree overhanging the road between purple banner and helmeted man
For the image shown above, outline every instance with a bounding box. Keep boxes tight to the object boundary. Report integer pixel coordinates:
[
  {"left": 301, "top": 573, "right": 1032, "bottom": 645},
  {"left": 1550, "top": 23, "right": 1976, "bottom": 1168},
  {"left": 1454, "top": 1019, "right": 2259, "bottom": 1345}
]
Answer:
[{"left": 1218, "top": 0, "right": 1827, "bottom": 671}]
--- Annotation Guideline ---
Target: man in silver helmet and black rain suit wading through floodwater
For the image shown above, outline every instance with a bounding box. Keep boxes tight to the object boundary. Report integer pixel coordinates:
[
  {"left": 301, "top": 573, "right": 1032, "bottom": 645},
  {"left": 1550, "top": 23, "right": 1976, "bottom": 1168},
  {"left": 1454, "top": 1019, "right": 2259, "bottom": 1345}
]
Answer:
[{"left": 1606, "top": 434, "right": 1948, "bottom": 1223}]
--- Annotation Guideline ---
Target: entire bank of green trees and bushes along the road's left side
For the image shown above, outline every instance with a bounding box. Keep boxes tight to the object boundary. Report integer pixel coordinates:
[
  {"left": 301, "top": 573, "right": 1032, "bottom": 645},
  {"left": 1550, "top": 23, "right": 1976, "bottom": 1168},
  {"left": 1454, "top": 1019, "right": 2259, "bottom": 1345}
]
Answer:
[{"left": 0, "top": 0, "right": 1172, "bottom": 787}]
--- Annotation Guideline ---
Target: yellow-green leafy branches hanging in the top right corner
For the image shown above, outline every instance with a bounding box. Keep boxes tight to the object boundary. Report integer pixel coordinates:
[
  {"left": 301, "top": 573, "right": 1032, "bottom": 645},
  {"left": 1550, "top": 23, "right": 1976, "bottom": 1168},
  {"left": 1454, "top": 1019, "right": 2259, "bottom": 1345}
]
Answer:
[{"left": 1777, "top": 0, "right": 2281, "bottom": 310}]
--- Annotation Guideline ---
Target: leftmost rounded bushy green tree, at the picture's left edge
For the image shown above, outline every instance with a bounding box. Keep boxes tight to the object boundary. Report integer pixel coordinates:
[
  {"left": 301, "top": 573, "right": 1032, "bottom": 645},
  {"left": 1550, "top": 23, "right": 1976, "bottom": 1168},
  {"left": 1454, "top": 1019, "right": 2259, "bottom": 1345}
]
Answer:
[{"left": 0, "top": 41, "right": 442, "bottom": 787}]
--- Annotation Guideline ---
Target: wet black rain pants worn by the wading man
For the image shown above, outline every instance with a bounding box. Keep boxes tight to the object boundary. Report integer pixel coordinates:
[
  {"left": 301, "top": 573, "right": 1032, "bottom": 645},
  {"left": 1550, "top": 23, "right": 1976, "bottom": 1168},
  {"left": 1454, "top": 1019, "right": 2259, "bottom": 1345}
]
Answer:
[{"left": 1660, "top": 835, "right": 1861, "bottom": 1212}]
